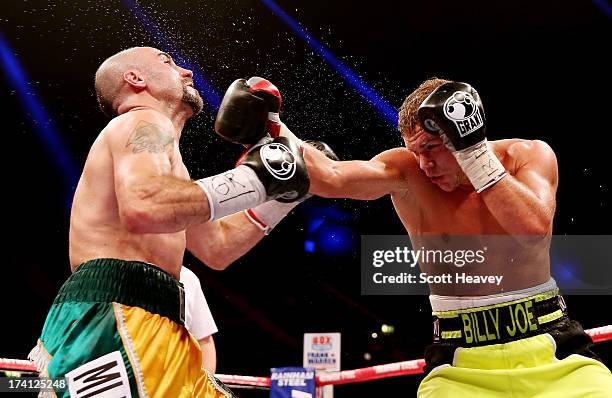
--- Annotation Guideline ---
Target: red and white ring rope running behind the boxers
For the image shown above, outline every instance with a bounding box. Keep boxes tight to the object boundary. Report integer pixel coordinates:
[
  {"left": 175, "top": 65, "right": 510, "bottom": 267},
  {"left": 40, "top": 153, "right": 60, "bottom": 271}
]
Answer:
[{"left": 0, "top": 325, "right": 612, "bottom": 388}]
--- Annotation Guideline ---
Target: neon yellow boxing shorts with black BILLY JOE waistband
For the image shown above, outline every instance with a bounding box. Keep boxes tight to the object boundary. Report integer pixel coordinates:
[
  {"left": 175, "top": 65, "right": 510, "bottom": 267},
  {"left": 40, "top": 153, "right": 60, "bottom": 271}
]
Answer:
[{"left": 418, "top": 290, "right": 612, "bottom": 398}]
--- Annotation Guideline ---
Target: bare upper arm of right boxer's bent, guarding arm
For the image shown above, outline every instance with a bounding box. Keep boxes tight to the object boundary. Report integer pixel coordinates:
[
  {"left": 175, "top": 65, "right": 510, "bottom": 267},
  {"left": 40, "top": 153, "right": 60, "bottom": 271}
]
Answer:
[{"left": 514, "top": 141, "right": 559, "bottom": 209}]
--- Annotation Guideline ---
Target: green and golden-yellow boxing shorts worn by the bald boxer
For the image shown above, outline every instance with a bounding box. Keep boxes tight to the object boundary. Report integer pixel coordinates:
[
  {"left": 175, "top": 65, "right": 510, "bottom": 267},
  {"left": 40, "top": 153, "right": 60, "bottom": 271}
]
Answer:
[{"left": 30, "top": 259, "right": 234, "bottom": 398}]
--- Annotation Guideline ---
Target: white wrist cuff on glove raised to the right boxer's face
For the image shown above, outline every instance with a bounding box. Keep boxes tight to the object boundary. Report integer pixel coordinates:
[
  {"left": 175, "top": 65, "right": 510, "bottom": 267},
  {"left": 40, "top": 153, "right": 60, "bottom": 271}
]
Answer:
[{"left": 453, "top": 140, "right": 507, "bottom": 193}]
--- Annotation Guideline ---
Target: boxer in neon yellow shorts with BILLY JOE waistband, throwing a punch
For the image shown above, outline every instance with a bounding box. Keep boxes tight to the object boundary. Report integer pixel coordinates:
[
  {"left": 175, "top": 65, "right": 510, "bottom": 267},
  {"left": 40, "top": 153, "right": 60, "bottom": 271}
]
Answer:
[{"left": 305, "top": 79, "right": 612, "bottom": 397}]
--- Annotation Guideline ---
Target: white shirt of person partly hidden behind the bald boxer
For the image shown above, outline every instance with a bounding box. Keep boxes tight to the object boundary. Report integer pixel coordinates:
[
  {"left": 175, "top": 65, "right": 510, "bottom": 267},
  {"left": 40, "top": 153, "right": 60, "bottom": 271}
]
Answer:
[{"left": 181, "top": 267, "right": 218, "bottom": 340}]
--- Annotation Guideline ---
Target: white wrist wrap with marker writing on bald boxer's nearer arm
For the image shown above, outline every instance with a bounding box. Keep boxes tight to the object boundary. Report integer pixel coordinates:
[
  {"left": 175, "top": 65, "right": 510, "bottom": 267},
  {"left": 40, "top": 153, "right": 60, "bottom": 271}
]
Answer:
[{"left": 194, "top": 165, "right": 266, "bottom": 221}]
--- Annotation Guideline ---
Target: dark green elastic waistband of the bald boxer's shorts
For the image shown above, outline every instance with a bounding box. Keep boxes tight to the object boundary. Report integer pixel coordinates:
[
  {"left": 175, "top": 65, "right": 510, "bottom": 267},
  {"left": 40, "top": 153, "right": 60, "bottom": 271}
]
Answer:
[{"left": 54, "top": 258, "right": 185, "bottom": 325}]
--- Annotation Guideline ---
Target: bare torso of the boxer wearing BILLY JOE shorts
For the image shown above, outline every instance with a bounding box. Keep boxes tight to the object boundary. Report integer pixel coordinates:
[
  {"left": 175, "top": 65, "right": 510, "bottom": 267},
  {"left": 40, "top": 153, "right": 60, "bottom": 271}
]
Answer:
[{"left": 391, "top": 140, "right": 550, "bottom": 296}]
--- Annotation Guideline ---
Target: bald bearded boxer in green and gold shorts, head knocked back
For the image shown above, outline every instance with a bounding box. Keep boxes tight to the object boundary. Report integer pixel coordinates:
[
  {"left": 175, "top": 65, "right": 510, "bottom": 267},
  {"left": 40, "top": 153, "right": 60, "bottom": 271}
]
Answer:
[{"left": 30, "top": 47, "right": 309, "bottom": 397}]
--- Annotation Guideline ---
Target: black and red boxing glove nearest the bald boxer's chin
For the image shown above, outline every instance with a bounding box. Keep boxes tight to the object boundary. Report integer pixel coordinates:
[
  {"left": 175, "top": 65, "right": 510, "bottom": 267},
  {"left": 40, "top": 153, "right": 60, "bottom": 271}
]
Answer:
[{"left": 215, "top": 77, "right": 282, "bottom": 145}]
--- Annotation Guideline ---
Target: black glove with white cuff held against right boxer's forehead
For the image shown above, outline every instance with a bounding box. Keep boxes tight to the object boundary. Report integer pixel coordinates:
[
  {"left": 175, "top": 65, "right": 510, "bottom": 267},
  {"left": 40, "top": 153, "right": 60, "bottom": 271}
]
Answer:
[{"left": 418, "top": 82, "right": 507, "bottom": 192}]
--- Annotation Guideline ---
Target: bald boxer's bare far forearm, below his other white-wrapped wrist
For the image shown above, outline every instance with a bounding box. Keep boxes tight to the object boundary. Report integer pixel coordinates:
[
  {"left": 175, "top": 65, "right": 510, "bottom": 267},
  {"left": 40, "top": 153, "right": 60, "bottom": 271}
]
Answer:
[{"left": 187, "top": 212, "right": 265, "bottom": 270}]
